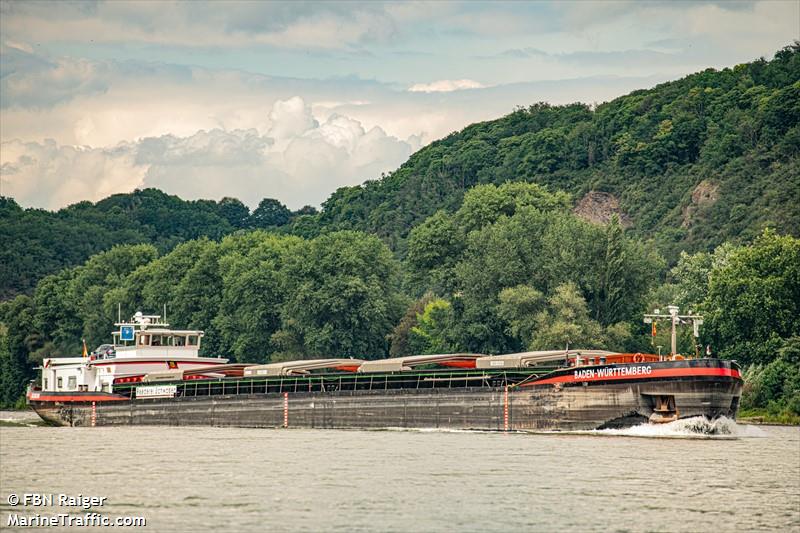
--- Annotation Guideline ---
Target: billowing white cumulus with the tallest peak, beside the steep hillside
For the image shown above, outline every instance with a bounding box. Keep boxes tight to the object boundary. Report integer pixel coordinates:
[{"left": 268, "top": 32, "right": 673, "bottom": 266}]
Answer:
[{"left": 138, "top": 102, "right": 413, "bottom": 208}]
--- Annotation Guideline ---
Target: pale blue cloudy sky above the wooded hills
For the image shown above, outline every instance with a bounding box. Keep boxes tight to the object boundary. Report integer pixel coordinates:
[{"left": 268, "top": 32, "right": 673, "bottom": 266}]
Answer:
[{"left": 0, "top": 0, "right": 800, "bottom": 209}]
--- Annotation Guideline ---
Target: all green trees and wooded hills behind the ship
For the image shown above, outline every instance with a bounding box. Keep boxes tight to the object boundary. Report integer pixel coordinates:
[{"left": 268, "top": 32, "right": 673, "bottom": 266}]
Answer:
[{"left": 0, "top": 44, "right": 800, "bottom": 416}]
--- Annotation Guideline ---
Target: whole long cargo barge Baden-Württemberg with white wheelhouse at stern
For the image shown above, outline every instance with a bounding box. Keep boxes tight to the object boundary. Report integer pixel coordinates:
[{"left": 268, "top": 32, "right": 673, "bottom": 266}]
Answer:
[{"left": 27, "top": 313, "right": 742, "bottom": 431}]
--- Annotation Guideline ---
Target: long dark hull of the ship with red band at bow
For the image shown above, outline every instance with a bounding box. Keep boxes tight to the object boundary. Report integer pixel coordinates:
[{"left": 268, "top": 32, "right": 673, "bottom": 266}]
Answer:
[{"left": 29, "top": 361, "right": 742, "bottom": 431}]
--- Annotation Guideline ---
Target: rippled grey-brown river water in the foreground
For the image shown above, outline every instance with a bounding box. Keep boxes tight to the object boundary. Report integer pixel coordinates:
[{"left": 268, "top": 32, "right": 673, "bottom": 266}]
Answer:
[{"left": 0, "top": 413, "right": 800, "bottom": 533}]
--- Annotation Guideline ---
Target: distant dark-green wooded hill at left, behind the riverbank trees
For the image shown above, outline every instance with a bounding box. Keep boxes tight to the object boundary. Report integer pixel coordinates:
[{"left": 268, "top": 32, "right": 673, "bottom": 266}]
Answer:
[{"left": 0, "top": 189, "right": 316, "bottom": 300}]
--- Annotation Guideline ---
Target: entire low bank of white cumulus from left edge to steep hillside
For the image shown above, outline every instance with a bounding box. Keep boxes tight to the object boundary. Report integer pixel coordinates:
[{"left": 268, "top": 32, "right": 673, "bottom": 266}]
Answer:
[{"left": 0, "top": 97, "right": 418, "bottom": 209}]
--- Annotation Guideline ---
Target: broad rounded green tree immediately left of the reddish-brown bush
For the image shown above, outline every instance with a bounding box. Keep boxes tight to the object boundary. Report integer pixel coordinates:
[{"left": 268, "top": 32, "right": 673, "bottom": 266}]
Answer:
[{"left": 275, "top": 231, "right": 403, "bottom": 359}]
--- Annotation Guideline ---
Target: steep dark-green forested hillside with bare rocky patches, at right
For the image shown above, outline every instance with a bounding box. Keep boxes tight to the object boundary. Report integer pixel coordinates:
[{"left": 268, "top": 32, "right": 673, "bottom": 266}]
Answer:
[{"left": 320, "top": 43, "right": 800, "bottom": 261}]
